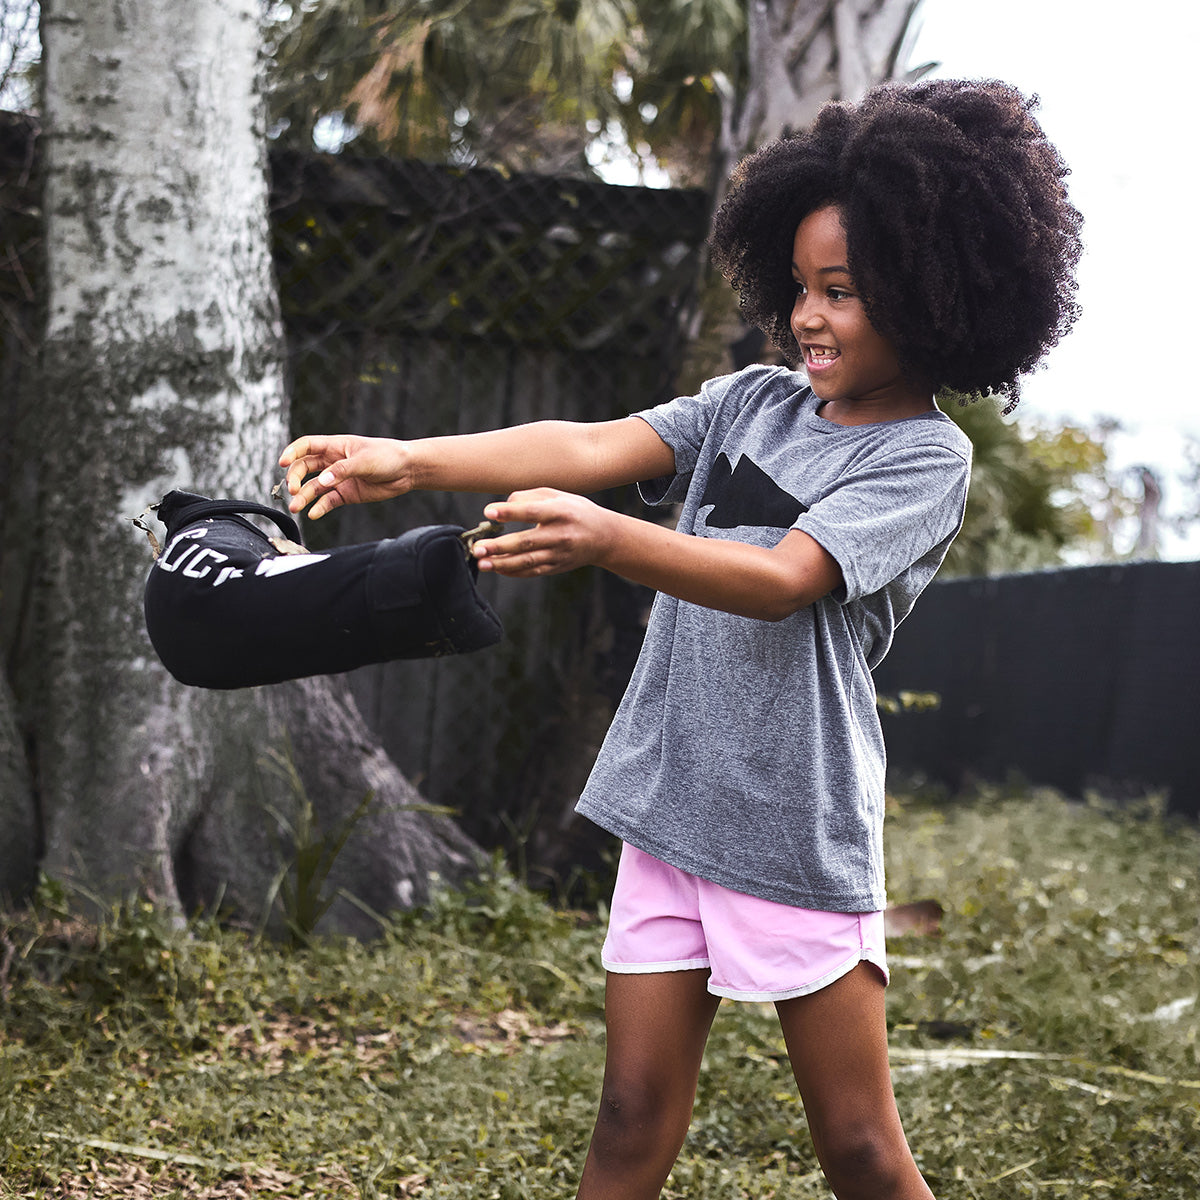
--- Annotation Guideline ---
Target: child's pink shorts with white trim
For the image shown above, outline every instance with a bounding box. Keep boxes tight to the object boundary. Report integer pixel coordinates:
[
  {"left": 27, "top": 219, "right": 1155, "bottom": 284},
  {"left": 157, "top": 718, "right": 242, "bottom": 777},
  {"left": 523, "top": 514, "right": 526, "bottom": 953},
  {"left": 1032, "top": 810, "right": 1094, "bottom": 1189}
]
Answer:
[{"left": 601, "top": 845, "right": 888, "bottom": 1001}]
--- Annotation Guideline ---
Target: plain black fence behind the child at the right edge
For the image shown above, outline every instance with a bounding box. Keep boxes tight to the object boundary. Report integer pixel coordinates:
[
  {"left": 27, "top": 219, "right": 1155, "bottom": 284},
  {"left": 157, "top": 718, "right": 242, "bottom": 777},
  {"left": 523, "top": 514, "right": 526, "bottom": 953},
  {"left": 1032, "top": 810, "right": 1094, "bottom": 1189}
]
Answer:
[{"left": 876, "top": 563, "right": 1200, "bottom": 815}]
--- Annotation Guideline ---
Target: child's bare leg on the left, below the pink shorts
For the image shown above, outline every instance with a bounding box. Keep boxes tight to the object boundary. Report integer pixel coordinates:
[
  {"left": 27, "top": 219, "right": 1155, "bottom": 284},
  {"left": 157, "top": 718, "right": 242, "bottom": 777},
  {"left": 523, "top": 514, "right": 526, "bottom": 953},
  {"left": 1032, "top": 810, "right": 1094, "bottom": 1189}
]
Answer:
[{"left": 578, "top": 970, "right": 720, "bottom": 1200}]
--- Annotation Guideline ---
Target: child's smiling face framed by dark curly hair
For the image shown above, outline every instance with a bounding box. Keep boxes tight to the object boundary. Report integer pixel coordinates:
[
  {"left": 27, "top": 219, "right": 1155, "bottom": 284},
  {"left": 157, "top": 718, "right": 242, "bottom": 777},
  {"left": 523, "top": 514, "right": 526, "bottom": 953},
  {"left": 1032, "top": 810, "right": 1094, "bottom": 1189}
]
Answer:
[{"left": 792, "top": 204, "right": 934, "bottom": 425}]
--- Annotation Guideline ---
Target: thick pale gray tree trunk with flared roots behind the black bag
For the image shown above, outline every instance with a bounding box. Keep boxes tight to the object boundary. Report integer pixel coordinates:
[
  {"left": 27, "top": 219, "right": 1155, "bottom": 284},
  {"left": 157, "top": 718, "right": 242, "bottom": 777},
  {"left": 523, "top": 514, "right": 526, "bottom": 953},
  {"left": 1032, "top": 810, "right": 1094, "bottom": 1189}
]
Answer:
[{"left": 28, "top": 0, "right": 474, "bottom": 932}]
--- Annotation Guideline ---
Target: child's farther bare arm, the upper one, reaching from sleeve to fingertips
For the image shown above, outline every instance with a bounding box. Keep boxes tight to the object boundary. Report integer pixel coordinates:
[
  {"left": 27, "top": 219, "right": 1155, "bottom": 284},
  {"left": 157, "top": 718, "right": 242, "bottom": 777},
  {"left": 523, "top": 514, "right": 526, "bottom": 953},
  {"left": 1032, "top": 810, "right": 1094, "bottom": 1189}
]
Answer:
[{"left": 280, "top": 416, "right": 674, "bottom": 518}]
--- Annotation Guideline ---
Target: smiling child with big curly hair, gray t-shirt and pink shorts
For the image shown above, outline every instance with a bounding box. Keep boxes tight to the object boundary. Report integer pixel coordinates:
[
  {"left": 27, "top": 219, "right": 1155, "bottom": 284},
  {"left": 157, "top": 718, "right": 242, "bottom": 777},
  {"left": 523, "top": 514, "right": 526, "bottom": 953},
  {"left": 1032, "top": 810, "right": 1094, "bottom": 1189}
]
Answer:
[{"left": 280, "top": 82, "right": 1080, "bottom": 1200}]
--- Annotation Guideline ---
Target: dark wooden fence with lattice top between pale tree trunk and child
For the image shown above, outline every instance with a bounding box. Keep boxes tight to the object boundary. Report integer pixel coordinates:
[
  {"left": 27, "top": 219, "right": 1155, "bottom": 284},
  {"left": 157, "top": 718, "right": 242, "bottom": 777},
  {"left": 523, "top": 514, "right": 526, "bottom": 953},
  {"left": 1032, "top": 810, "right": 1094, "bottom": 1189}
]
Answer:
[{"left": 272, "top": 155, "right": 707, "bottom": 872}]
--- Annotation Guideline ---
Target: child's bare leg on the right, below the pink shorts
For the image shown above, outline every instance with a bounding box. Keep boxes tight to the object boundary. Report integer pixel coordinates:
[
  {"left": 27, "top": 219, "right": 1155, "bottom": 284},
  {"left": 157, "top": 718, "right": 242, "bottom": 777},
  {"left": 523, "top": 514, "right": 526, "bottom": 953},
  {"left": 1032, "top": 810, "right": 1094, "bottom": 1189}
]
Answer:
[{"left": 775, "top": 962, "right": 932, "bottom": 1200}]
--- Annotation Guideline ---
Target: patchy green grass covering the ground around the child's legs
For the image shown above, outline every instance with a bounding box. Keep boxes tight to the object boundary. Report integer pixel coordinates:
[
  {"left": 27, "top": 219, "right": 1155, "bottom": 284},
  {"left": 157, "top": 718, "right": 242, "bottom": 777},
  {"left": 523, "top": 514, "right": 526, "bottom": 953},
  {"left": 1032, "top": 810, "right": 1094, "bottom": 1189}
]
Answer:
[{"left": 0, "top": 791, "right": 1200, "bottom": 1200}]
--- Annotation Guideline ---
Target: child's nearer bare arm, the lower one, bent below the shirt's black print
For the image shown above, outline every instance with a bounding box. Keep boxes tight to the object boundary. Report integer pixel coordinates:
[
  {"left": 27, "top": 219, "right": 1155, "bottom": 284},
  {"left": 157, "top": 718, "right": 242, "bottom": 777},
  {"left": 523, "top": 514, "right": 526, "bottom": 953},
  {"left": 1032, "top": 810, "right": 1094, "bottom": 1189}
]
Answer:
[{"left": 474, "top": 487, "right": 842, "bottom": 620}]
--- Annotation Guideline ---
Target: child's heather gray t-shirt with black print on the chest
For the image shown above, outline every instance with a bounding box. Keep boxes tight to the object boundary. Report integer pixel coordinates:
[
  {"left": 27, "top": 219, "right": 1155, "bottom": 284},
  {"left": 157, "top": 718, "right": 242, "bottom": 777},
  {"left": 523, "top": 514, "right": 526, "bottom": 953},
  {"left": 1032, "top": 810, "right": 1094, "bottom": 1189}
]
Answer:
[{"left": 577, "top": 366, "right": 971, "bottom": 912}]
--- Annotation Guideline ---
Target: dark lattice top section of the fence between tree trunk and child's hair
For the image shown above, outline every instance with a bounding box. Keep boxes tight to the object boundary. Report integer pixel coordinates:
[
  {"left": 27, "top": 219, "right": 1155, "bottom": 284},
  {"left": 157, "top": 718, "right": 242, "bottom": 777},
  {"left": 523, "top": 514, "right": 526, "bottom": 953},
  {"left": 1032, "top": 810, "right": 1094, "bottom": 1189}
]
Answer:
[{"left": 272, "top": 155, "right": 706, "bottom": 360}]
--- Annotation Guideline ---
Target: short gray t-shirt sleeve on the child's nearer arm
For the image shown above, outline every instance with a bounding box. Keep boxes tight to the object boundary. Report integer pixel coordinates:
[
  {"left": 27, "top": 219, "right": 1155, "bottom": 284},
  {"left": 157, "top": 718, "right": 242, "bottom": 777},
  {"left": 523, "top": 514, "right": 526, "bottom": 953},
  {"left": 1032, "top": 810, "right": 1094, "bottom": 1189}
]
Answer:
[{"left": 793, "top": 444, "right": 971, "bottom": 602}]
